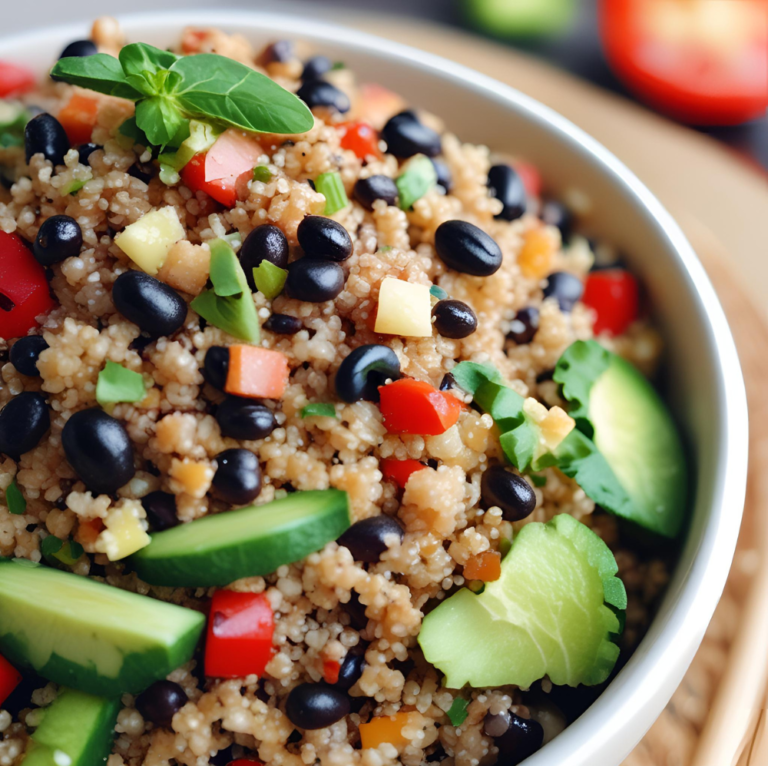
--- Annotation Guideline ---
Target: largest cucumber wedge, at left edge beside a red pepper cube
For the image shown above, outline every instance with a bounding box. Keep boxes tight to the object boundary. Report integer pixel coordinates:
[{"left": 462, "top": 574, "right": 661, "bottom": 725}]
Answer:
[{"left": 0, "top": 559, "right": 205, "bottom": 697}]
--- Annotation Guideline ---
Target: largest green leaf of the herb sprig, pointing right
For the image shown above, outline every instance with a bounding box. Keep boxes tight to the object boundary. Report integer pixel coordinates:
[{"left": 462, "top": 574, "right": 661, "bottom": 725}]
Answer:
[{"left": 171, "top": 53, "right": 315, "bottom": 134}]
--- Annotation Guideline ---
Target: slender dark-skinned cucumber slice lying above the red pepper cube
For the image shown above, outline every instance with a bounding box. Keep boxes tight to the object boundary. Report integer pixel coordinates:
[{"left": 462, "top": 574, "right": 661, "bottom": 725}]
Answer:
[{"left": 129, "top": 489, "right": 351, "bottom": 587}]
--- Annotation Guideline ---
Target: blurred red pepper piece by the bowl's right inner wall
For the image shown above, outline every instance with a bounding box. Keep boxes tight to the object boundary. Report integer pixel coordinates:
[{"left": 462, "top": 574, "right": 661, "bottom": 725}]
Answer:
[{"left": 581, "top": 269, "right": 640, "bottom": 335}]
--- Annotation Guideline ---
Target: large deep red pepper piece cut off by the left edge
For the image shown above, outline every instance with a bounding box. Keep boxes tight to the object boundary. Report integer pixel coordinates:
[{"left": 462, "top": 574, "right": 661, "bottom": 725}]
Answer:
[{"left": 0, "top": 231, "right": 56, "bottom": 340}]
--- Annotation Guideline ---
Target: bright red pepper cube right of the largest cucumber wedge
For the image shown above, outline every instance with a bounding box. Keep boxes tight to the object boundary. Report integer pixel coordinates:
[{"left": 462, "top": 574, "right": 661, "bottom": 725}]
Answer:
[{"left": 205, "top": 590, "right": 275, "bottom": 678}]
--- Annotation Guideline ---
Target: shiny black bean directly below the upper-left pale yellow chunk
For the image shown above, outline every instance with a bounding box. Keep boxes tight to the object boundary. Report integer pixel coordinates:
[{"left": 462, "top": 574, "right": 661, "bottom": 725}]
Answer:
[{"left": 112, "top": 271, "right": 187, "bottom": 338}]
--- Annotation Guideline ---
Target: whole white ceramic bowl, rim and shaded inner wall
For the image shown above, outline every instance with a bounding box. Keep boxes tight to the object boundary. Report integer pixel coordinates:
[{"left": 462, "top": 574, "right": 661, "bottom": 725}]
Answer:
[{"left": 0, "top": 11, "right": 747, "bottom": 766}]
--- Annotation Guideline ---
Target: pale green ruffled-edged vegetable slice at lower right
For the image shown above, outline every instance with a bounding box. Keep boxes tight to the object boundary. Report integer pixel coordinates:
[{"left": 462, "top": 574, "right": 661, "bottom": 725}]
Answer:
[{"left": 419, "top": 514, "right": 627, "bottom": 689}]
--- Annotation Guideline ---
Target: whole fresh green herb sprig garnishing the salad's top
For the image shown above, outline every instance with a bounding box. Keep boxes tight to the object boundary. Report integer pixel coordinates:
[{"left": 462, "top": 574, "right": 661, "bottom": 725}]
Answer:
[{"left": 51, "top": 43, "right": 314, "bottom": 146}]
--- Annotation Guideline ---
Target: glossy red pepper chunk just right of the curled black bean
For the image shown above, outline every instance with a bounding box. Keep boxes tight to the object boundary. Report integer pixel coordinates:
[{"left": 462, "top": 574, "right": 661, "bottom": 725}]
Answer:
[{"left": 379, "top": 378, "right": 463, "bottom": 436}]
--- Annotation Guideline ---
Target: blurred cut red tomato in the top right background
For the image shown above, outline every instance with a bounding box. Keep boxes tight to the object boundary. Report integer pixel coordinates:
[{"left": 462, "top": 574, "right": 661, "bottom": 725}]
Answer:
[{"left": 600, "top": 0, "right": 768, "bottom": 125}]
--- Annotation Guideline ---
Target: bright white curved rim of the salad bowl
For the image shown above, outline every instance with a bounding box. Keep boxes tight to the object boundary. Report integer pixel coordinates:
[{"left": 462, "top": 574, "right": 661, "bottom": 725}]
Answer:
[{"left": 0, "top": 9, "right": 748, "bottom": 766}]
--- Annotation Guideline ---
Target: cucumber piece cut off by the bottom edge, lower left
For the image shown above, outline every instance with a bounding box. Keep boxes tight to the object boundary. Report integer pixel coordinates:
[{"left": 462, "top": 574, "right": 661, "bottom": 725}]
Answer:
[{"left": 24, "top": 688, "right": 120, "bottom": 766}]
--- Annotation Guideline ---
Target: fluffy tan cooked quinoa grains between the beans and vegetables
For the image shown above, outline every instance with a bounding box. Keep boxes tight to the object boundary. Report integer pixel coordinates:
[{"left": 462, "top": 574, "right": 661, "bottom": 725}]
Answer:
[{"left": 0, "top": 19, "right": 670, "bottom": 766}]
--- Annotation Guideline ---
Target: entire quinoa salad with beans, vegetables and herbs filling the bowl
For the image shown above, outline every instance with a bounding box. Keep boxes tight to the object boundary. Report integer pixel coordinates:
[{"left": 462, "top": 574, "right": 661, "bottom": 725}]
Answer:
[{"left": 0, "top": 18, "right": 688, "bottom": 766}]
